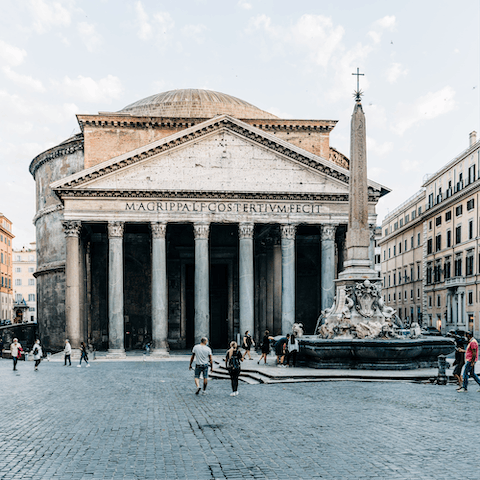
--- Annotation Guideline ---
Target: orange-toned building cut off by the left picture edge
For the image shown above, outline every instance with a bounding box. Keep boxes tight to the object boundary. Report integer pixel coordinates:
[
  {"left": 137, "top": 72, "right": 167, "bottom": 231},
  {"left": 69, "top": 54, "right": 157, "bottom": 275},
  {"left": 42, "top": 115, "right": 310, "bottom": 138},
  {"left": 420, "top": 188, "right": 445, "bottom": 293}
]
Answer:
[{"left": 0, "top": 213, "right": 14, "bottom": 321}]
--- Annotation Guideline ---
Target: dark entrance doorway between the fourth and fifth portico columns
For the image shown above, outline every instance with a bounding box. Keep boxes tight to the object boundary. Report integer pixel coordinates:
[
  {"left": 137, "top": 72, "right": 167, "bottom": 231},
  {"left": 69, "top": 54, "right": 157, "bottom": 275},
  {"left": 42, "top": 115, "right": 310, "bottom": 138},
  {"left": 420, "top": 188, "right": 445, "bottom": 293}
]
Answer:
[{"left": 210, "top": 263, "right": 228, "bottom": 349}]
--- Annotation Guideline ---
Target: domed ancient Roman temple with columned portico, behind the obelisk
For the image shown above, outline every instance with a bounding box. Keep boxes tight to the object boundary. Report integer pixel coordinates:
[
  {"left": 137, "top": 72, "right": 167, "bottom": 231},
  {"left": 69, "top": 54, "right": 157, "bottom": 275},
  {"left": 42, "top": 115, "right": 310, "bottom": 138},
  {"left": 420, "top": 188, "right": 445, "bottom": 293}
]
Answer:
[{"left": 30, "top": 89, "right": 389, "bottom": 356}]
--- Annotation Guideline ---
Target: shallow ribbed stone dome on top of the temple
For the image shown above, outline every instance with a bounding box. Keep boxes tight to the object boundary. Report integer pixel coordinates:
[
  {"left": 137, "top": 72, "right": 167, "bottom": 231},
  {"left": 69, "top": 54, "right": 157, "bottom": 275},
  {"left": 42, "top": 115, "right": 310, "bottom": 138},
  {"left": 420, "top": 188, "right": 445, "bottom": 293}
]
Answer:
[{"left": 119, "top": 88, "right": 278, "bottom": 119}]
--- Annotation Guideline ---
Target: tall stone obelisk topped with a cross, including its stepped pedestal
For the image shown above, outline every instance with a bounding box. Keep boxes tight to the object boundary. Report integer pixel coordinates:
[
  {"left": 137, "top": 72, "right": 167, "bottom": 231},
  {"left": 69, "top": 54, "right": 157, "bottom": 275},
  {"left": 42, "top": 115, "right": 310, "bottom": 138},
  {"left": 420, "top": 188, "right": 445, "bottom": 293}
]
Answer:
[{"left": 339, "top": 68, "right": 378, "bottom": 279}]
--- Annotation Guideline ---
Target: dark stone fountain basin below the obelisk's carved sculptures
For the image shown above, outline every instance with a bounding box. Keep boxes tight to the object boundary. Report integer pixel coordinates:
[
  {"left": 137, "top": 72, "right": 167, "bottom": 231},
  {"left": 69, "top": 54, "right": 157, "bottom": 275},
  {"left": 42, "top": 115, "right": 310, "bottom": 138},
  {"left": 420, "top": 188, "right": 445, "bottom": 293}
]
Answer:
[{"left": 299, "top": 335, "right": 455, "bottom": 370}]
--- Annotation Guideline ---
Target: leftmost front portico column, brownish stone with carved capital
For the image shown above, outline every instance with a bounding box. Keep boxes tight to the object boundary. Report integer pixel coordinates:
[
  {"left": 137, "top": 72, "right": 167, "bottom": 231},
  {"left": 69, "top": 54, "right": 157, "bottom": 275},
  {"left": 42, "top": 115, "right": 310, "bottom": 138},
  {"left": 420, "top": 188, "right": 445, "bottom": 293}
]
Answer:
[{"left": 63, "top": 220, "right": 84, "bottom": 348}]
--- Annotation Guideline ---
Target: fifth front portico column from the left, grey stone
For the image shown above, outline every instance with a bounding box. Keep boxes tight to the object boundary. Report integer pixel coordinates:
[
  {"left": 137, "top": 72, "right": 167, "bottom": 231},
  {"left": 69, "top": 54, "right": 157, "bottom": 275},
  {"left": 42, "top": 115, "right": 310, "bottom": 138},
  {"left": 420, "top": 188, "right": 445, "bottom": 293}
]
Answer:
[{"left": 238, "top": 223, "right": 255, "bottom": 336}]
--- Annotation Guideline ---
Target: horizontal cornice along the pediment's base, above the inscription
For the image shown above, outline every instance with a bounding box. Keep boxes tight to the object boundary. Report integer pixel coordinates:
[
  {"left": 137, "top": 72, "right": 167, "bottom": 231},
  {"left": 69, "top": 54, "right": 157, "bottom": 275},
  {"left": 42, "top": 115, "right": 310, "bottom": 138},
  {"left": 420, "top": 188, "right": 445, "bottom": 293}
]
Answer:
[{"left": 52, "top": 188, "right": 377, "bottom": 202}]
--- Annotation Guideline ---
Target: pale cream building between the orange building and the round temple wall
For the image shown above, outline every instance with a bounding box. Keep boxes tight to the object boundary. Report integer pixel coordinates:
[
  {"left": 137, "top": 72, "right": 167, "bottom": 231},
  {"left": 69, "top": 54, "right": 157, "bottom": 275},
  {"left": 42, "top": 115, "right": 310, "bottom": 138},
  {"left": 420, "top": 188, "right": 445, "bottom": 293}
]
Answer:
[{"left": 12, "top": 242, "right": 37, "bottom": 323}]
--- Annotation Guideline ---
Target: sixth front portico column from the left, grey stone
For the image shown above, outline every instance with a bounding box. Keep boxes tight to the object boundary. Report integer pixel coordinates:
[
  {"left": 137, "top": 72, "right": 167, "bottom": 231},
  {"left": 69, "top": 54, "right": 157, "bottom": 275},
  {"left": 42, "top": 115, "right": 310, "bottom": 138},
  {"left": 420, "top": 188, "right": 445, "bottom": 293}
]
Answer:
[{"left": 281, "top": 225, "right": 296, "bottom": 335}]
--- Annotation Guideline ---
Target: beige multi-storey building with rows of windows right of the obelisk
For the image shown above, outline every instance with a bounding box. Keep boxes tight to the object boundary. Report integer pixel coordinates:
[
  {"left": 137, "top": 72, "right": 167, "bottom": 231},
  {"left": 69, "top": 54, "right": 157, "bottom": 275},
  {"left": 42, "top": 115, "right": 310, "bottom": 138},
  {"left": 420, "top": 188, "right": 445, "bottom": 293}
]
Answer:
[{"left": 380, "top": 132, "right": 480, "bottom": 334}]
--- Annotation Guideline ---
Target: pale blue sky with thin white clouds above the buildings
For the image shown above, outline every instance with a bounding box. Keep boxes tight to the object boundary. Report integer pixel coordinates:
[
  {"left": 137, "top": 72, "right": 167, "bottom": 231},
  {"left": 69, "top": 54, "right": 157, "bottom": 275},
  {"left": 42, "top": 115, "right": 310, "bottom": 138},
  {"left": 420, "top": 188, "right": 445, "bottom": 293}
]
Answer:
[{"left": 0, "top": 0, "right": 480, "bottom": 248}]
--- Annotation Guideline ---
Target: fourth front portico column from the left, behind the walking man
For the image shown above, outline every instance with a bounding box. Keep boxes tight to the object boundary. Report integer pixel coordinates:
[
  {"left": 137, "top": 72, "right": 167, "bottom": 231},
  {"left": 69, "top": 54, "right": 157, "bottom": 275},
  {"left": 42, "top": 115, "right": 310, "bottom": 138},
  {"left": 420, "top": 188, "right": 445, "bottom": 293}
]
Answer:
[{"left": 193, "top": 223, "right": 210, "bottom": 343}]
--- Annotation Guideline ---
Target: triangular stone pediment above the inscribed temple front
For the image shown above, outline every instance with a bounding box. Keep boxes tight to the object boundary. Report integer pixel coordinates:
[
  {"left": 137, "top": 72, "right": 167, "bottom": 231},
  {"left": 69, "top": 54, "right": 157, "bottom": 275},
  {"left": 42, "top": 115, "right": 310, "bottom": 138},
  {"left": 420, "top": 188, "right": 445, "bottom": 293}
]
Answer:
[{"left": 51, "top": 116, "right": 386, "bottom": 196}]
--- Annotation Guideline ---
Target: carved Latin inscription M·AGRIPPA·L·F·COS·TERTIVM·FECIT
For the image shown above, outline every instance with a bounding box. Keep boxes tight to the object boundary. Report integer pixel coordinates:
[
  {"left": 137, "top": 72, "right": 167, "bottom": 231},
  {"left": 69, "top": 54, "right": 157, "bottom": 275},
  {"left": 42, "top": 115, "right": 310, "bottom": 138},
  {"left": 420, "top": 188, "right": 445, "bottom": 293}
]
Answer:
[{"left": 125, "top": 202, "right": 320, "bottom": 215}]
